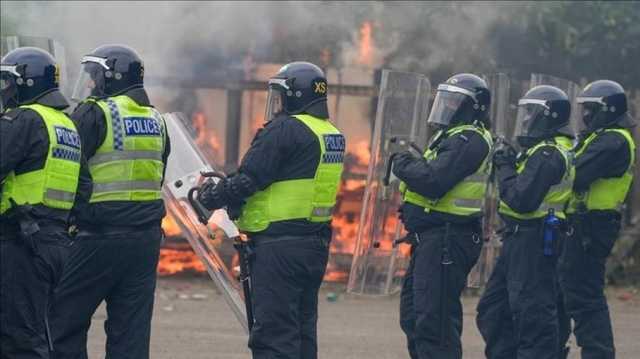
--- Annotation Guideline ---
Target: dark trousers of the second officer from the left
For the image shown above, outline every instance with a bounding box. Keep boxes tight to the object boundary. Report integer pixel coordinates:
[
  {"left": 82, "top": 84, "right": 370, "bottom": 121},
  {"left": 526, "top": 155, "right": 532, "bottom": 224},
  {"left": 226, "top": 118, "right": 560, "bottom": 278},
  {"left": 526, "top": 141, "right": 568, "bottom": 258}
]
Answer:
[{"left": 51, "top": 225, "right": 162, "bottom": 359}]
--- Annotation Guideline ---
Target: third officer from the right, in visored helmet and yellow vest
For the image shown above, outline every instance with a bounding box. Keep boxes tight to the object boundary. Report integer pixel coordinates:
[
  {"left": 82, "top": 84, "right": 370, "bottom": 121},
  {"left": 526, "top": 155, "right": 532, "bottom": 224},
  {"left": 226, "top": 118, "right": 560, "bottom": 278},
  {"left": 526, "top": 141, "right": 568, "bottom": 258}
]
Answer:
[{"left": 393, "top": 74, "right": 493, "bottom": 359}]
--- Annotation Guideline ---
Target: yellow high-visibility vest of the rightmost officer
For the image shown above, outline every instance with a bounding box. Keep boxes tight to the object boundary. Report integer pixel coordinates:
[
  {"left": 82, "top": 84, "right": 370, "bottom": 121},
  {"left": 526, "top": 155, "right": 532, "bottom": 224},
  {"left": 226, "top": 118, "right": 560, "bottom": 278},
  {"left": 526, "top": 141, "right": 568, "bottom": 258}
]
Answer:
[{"left": 569, "top": 128, "right": 636, "bottom": 213}]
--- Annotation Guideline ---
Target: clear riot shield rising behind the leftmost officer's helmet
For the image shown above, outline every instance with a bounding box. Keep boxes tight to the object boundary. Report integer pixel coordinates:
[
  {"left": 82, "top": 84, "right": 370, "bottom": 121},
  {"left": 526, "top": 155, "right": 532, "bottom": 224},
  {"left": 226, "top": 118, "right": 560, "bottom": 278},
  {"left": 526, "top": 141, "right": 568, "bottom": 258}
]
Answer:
[{"left": 0, "top": 36, "right": 71, "bottom": 94}]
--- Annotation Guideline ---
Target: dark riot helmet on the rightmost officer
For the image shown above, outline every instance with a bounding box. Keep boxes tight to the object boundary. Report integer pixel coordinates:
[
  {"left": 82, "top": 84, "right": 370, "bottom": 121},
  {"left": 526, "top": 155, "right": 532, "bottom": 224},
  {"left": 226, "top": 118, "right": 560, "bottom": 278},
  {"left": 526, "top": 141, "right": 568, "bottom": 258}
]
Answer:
[{"left": 576, "top": 80, "right": 634, "bottom": 133}]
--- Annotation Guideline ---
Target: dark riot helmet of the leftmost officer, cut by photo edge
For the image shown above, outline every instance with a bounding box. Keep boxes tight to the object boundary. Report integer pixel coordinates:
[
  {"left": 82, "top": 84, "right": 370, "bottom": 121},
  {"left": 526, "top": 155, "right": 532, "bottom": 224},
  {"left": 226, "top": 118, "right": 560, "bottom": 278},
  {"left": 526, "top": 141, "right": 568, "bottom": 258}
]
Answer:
[{"left": 0, "top": 47, "right": 66, "bottom": 109}]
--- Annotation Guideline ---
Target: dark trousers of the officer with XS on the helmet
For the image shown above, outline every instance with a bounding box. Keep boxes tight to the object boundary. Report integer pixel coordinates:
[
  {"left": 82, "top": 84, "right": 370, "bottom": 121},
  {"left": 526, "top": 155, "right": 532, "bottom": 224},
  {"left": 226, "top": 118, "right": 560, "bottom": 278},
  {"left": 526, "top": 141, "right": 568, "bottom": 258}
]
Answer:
[{"left": 249, "top": 235, "right": 330, "bottom": 359}]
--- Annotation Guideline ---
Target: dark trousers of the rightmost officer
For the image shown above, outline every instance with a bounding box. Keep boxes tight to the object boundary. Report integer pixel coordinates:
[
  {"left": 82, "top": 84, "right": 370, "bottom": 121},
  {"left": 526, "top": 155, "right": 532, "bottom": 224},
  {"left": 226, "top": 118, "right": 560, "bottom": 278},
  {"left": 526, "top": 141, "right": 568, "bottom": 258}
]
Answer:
[{"left": 558, "top": 214, "right": 620, "bottom": 359}]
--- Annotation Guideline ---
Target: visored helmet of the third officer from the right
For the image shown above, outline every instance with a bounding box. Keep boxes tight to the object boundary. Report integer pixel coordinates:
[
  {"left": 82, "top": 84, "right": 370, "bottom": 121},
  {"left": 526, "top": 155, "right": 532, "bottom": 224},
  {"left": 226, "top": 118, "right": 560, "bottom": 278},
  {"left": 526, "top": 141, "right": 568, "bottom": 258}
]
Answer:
[{"left": 427, "top": 74, "right": 491, "bottom": 128}]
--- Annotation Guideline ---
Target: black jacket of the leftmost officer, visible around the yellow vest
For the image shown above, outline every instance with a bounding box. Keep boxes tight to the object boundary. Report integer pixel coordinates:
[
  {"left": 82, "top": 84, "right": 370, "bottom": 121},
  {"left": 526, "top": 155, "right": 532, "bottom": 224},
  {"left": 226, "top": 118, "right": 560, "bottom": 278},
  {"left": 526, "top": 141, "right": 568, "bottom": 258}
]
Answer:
[{"left": 0, "top": 94, "right": 69, "bottom": 235}]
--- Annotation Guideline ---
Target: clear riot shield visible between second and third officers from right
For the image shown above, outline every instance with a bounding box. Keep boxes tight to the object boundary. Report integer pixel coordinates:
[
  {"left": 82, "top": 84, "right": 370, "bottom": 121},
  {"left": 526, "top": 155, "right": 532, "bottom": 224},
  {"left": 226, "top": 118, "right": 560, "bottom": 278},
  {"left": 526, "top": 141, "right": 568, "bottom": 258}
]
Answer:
[{"left": 467, "top": 73, "right": 515, "bottom": 288}]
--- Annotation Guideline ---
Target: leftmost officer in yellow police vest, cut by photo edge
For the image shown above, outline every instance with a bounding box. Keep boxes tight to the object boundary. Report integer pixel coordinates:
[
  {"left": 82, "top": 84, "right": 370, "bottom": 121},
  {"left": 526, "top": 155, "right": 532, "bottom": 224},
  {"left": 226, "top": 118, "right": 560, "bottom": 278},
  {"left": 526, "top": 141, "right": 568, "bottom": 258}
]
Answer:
[{"left": 0, "top": 47, "right": 81, "bottom": 359}]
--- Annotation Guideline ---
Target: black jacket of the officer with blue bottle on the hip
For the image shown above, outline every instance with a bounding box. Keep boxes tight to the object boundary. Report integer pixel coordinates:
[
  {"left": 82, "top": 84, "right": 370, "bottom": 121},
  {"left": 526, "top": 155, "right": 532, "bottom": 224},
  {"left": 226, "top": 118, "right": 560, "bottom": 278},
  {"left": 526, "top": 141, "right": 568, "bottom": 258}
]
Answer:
[{"left": 496, "top": 141, "right": 566, "bottom": 223}]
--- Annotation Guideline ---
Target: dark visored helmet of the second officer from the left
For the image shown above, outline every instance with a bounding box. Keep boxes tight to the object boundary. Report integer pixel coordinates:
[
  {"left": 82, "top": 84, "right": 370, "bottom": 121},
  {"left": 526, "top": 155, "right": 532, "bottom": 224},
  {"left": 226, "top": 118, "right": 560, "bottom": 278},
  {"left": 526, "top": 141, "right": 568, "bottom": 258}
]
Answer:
[{"left": 72, "top": 45, "right": 144, "bottom": 101}]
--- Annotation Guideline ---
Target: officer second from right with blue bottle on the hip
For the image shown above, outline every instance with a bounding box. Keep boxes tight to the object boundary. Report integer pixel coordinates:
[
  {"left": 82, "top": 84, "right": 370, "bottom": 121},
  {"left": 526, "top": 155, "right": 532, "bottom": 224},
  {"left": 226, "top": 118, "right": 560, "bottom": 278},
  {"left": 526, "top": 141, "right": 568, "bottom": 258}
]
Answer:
[{"left": 477, "top": 85, "right": 574, "bottom": 359}]
